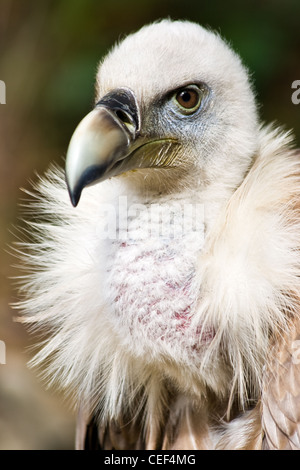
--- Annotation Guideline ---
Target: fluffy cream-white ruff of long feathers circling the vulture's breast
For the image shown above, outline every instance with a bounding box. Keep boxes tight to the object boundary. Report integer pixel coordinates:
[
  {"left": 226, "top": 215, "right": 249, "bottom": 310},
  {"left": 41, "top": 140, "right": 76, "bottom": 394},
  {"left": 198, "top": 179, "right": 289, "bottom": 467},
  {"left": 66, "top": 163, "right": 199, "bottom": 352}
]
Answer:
[{"left": 14, "top": 125, "right": 300, "bottom": 427}]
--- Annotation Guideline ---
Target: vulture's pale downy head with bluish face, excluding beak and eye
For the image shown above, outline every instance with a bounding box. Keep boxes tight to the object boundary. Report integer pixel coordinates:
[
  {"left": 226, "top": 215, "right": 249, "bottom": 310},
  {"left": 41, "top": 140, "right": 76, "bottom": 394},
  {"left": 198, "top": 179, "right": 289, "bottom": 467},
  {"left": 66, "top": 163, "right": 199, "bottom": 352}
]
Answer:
[{"left": 97, "top": 20, "right": 258, "bottom": 188}]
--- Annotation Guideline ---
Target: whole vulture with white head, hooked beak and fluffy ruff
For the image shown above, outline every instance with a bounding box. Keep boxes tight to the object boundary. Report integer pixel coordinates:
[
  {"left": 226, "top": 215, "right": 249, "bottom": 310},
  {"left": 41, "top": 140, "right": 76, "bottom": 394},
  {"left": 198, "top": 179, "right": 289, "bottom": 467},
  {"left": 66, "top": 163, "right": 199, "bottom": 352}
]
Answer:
[{"left": 17, "top": 19, "right": 300, "bottom": 450}]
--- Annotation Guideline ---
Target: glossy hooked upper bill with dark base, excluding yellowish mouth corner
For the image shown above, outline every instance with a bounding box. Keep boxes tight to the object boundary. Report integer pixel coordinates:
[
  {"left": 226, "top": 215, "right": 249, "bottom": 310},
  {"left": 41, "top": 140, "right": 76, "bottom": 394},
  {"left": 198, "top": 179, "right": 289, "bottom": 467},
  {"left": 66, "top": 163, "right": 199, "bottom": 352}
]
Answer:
[{"left": 66, "top": 89, "right": 139, "bottom": 207}]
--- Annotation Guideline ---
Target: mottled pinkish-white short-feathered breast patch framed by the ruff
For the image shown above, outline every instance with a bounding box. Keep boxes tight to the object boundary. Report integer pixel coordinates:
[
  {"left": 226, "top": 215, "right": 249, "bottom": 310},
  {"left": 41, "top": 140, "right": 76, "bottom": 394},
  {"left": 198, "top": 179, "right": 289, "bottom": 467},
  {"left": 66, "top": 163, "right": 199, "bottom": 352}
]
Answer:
[{"left": 105, "top": 194, "right": 213, "bottom": 358}]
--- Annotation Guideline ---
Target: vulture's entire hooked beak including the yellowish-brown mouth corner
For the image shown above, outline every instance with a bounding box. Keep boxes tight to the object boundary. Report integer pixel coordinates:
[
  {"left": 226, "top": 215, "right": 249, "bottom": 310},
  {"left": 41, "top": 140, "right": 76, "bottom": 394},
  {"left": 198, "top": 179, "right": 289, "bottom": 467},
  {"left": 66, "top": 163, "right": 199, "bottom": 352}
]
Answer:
[{"left": 66, "top": 88, "right": 178, "bottom": 207}]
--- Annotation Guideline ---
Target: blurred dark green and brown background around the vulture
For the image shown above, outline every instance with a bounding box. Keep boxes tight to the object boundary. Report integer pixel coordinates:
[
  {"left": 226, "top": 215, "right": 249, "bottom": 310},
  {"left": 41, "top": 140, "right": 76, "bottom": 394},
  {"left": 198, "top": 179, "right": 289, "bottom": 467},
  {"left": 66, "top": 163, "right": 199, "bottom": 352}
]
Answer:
[{"left": 0, "top": 0, "right": 300, "bottom": 450}]
